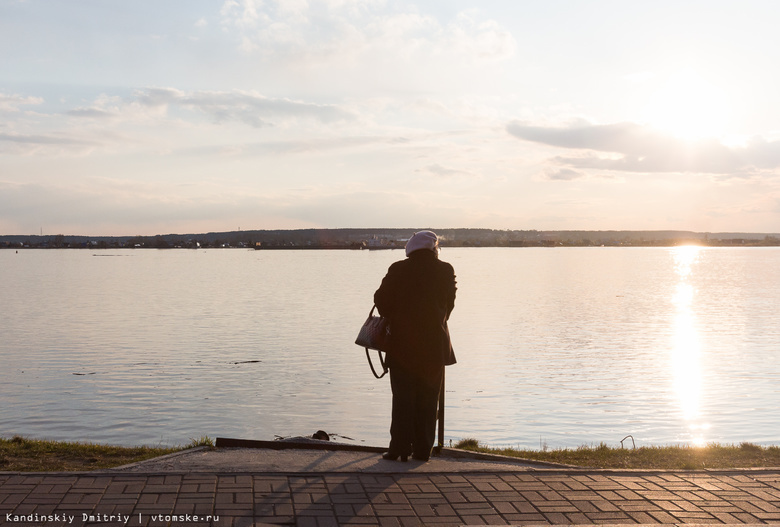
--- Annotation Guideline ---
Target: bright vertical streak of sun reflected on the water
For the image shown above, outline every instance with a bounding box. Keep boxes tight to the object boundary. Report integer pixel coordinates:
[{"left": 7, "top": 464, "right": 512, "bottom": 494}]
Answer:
[{"left": 671, "top": 246, "right": 709, "bottom": 446}]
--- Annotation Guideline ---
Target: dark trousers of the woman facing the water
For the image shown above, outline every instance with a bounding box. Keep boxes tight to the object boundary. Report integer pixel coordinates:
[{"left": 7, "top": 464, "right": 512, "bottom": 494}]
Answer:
[{"left": 390, "top": 365, "right": 444, "bottom": 459}]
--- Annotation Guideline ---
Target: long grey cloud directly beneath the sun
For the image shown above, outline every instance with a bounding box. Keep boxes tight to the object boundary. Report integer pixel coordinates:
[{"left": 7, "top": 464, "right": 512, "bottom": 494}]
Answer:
[{"left": 507, "top": 121, "right": 780, "bottom": 179}]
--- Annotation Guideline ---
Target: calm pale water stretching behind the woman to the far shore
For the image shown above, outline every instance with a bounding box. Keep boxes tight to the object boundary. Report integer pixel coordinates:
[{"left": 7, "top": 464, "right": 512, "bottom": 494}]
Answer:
[{"left": 0, "top": 248, "right": 780, "bottom": 448}]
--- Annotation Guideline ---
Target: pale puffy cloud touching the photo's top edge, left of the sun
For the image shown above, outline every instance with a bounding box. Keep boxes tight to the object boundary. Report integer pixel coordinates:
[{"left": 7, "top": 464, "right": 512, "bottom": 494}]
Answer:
[{"left": 221, "top": 0, "right": 516, "bottom": 61}]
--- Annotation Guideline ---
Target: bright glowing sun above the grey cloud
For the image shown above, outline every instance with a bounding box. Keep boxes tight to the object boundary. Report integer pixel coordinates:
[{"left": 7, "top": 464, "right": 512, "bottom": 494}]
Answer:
[{"left": 643, "top": 69, "right": 729, "bottom": 140}]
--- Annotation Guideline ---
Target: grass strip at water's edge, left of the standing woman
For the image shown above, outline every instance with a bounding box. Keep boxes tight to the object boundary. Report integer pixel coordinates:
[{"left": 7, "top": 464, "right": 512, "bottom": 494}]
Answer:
[{"left": 0, "top": 436, "right": 214, "bottom": 472}]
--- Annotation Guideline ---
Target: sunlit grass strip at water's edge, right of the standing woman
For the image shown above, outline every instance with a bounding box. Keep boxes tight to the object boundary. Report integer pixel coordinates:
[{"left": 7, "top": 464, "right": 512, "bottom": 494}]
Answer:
[{"left": 455, "top": 439, "right": 780, "bottom": 470}]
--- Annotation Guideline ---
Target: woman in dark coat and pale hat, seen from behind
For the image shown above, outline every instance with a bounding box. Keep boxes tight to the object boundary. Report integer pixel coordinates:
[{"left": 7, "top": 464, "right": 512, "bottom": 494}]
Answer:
[{"left": 374, "top": 231, "right": 456, "bottom": 461}]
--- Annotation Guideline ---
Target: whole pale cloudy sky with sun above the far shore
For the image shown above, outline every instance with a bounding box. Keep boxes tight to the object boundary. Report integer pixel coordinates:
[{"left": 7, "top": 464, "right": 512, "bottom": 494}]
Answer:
[{"left": 0, "top": 0, "right": 780, "bottom": 236}]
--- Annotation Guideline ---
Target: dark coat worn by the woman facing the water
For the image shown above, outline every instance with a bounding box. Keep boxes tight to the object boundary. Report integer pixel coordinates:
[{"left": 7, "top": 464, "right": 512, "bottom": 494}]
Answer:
[{"left": 374, "top": 249, "right": 456, "bottom": 377}]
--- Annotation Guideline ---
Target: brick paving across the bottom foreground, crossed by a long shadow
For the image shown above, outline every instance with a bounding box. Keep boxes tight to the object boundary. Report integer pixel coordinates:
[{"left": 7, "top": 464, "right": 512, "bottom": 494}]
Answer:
[{"left": 0, "top": 470, "right": 780, "bottom": 527}]
